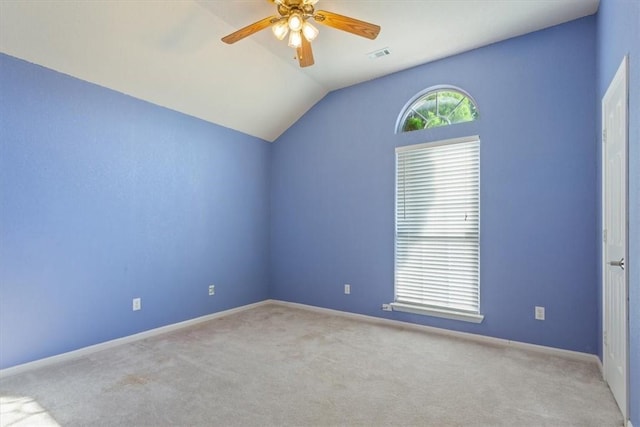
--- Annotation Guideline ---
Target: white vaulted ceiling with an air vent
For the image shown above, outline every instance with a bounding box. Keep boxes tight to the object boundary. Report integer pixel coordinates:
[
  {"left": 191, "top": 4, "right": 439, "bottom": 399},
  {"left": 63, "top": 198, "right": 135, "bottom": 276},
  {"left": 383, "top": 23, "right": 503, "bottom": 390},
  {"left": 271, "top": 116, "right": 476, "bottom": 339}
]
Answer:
[{"left": 0, "top": 0, "right": 599, "bottom": 141}]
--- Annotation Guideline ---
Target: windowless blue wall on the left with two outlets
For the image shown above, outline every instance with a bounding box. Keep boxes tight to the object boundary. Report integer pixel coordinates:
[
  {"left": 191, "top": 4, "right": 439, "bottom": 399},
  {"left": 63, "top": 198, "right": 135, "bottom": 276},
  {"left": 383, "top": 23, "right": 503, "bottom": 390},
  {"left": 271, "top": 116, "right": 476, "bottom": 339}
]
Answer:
[{"left": 0, "top": 55, "right": 270, "bottom": 368}]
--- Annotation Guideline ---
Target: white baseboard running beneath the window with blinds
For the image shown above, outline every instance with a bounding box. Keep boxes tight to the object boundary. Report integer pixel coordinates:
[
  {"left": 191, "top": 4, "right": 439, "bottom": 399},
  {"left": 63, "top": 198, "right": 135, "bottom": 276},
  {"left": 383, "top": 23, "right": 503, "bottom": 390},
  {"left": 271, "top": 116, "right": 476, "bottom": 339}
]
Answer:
[{"left": 267, "top": 300, "right": 600, "bottom": 363}]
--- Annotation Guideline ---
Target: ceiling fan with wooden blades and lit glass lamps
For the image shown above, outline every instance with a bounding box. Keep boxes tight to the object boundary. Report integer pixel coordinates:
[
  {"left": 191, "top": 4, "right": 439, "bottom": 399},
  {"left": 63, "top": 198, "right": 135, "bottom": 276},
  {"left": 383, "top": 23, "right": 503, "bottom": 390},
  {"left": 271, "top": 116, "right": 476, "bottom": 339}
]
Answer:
[{"left": 222, "top": 0, "right": 380, "bottom": 67}]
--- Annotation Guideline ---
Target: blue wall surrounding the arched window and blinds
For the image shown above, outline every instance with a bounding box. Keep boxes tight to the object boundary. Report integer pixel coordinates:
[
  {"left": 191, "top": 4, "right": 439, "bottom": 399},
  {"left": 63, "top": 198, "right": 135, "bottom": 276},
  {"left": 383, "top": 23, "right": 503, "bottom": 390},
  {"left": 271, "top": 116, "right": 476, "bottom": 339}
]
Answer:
[{"left": 270, "top": 16, "right": 598, "bottom": 353}]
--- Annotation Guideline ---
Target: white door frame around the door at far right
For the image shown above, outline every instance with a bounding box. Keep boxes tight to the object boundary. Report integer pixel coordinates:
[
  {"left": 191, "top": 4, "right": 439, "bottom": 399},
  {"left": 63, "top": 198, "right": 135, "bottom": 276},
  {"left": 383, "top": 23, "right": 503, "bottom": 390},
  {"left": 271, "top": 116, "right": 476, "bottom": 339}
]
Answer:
[{"left": 600, "top": 55, "right": 630, "bottom": 426}]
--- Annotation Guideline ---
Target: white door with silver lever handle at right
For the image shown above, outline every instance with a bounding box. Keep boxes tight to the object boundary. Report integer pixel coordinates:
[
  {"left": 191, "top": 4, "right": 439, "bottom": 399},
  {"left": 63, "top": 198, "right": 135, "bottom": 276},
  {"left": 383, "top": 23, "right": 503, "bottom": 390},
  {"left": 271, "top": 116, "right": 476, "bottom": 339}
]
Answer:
[{"left": 602, "top": 57, "right": 628, "bottom": 420}]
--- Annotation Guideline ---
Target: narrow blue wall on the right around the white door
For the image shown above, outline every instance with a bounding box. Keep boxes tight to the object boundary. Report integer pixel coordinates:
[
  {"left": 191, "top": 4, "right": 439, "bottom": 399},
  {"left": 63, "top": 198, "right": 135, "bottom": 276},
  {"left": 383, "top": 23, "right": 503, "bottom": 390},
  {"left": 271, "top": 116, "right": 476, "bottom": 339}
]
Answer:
[{"left": 596, "top": 0, "right": 640, "bottom": 426}]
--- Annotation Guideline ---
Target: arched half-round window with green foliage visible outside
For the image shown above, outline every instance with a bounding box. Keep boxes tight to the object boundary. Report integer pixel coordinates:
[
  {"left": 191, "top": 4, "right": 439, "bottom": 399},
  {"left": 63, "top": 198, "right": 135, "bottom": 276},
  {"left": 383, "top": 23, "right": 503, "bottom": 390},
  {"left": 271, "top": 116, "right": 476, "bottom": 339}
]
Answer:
[{"left": 396, "top": 86, "right": 478, "bottom": 133}]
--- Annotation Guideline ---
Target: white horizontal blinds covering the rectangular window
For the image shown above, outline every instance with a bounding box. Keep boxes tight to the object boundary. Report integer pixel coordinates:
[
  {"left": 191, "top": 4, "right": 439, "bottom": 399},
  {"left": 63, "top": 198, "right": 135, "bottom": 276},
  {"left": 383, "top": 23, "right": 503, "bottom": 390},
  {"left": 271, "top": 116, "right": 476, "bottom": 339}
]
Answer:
[{"left": 395, "top": 137, "right": 480, "bottom": 314}]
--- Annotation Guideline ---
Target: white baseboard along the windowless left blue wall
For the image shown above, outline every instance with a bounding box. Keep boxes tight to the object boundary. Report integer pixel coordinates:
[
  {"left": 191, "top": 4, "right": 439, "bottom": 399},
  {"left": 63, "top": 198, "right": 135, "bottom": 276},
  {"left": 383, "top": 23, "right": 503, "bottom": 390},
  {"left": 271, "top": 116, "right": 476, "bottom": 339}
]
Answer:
[{"left": 0, "top": 300, "right": 270, "bottom": 378}]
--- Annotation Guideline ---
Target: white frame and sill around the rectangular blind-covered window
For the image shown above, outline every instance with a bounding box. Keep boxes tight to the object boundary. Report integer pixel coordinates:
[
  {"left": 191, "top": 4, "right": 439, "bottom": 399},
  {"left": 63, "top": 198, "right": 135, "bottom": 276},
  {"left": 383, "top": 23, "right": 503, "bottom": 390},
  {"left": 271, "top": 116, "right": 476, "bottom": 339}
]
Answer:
[{"left": 391, "top": 135, "right": 484, "bottom": 323}]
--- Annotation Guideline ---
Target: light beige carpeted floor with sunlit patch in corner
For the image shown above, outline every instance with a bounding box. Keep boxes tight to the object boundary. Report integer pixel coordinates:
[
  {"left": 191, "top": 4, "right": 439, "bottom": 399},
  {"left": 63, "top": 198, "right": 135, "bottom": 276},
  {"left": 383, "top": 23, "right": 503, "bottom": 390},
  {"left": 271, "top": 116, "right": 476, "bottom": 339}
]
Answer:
[{"left": 0, "top": 304, "right": 622, "bottom": 427}]
